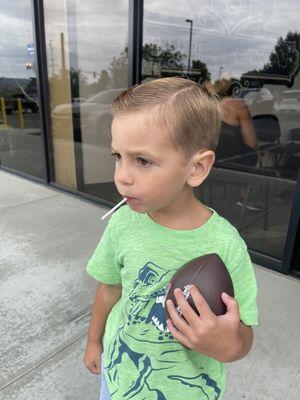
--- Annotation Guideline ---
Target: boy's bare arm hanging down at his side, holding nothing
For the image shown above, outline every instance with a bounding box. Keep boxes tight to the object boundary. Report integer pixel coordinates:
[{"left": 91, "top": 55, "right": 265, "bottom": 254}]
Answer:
[{"left": 84, "top": 283, "right": 122, "bottom": 374}]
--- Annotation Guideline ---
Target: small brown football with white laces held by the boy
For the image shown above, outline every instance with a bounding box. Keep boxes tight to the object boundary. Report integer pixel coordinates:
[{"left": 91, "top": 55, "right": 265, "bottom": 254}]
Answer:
[{"left": 165, "top": 253, "right": 234, "bottom": 318}]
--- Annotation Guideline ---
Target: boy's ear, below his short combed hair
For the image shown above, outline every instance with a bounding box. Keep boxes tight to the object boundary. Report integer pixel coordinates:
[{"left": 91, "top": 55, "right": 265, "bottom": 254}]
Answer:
[{"left": 187, "top": 150, "right": 215, "bottom": 187}]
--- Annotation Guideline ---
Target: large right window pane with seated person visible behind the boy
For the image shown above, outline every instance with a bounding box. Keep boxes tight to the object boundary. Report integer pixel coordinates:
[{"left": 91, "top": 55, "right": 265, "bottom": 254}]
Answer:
[{"left": 142, "top": 0, "right": 300, "bottom": 259}]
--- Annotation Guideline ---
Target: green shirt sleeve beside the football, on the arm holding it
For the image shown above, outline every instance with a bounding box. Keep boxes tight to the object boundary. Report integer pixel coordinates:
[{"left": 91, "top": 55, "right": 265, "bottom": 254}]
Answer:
[{"left": 226, "top": 243, "right": 258, "bottom": 326}]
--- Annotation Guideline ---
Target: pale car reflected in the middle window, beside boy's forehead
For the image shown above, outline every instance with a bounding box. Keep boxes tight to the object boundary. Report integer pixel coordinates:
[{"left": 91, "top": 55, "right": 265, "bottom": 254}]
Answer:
[{"left": 52, "top": 89, "right": 123, "bottom": 146}]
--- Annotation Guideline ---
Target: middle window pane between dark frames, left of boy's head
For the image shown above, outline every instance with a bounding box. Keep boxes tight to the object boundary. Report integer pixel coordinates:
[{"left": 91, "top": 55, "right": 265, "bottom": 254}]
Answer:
[{"left": 44, "top": 0, "right": 128, "bottom": 201}]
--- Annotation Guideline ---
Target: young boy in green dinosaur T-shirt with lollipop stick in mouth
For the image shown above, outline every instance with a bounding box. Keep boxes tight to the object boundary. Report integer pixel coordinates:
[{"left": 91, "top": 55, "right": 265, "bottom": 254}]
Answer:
[{"left": 84, "top": 78, "right": 257, "bottom": 400}]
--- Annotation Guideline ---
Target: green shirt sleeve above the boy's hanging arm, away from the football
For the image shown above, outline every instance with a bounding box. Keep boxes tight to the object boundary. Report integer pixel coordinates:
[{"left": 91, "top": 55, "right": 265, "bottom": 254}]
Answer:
[{"left": 86, "top": 221, "right": 122, "bottom": 285}]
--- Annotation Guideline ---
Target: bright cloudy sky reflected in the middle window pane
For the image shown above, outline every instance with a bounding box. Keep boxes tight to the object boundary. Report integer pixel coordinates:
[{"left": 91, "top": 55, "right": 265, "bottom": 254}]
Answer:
[{"left": 45, "top": 0, "right": 128, "bottom": 81}]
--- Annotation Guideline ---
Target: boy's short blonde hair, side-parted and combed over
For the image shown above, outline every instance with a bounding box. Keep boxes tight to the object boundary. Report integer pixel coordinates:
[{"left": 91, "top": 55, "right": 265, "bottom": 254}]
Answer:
[{"left": 112, "top": 77, "right": 222, "bottom": 157}]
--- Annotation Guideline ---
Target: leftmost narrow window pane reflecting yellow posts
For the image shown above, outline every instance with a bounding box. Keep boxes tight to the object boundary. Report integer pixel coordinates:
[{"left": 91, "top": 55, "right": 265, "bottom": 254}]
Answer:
[{"left": 0, "top": 0, "right": 45, "bottom": 179}]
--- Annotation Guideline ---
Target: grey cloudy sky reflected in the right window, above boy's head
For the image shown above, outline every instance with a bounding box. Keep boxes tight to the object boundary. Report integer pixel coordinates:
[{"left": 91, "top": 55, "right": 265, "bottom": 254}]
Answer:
[{"left": 144, "top": 0, "right": 300, "bottom": 79}]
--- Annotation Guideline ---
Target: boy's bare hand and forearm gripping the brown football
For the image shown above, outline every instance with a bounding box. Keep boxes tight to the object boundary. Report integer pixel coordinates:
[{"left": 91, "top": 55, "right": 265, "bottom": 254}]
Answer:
[{"left": 167, "top": 285, "right": 252, "bottom": 362}]
